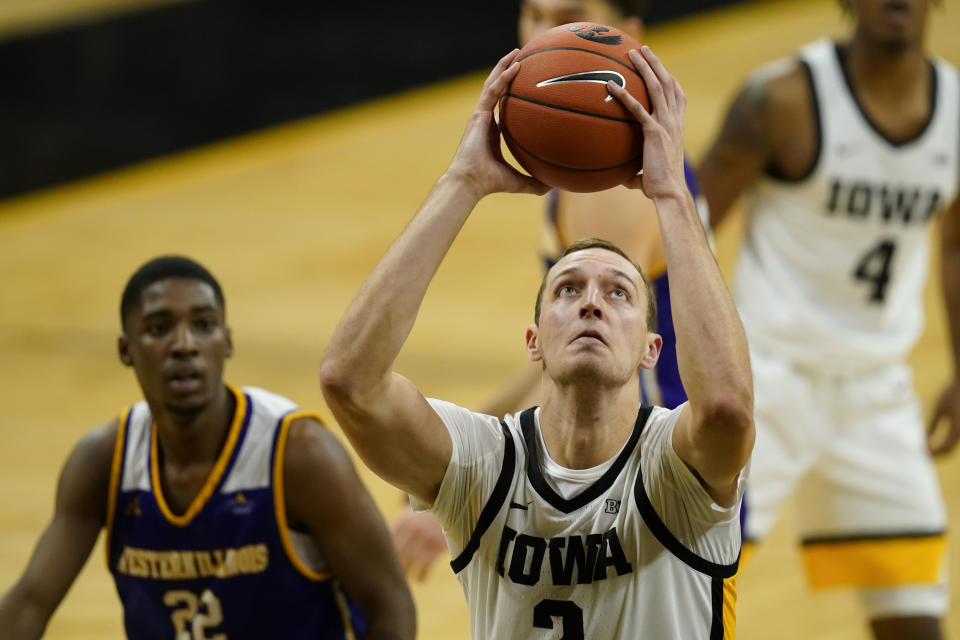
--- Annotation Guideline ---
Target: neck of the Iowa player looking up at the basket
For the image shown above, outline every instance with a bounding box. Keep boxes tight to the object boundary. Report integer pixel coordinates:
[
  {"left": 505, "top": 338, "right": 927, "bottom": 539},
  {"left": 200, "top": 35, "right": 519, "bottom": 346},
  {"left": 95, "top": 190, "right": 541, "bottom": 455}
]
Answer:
[{"left": 540, "top": 385, "right": 640, "bottom": 469}]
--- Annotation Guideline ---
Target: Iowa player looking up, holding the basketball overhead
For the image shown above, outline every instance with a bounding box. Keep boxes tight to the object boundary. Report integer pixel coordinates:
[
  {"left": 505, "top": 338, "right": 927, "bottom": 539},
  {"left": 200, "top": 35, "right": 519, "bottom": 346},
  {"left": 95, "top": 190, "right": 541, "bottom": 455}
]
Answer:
[{"left": 321, "top": 48, "right": 753, "bottom": 640}]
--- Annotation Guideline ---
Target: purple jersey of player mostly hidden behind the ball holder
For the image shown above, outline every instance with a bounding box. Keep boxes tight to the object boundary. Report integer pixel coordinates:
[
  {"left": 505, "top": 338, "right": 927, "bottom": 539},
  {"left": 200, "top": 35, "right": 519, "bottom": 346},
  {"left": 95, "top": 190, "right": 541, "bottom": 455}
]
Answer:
[{"left": 540, "top": 159, "right": 710, "bottom": 409}]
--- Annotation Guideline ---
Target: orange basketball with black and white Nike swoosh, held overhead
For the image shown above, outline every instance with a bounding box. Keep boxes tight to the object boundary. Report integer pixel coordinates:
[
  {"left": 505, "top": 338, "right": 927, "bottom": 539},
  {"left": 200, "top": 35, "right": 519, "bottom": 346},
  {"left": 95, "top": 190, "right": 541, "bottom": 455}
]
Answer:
[{"left": 500, "top": 22, "right": 650, "bottom": 192}]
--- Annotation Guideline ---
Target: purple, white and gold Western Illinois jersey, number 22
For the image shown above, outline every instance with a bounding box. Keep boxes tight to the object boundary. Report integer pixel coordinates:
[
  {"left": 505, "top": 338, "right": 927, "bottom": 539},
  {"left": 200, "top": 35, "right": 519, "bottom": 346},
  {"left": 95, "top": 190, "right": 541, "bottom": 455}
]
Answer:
[{"left": 107, "top": 387, "right": 366, "bottom": 640}]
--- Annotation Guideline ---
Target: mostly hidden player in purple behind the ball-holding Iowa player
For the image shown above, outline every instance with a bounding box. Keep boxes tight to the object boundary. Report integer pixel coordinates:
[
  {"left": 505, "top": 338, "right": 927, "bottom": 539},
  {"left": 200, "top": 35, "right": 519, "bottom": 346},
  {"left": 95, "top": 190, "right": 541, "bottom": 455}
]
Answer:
[{"left": 391, "top": 0, "right": 707, "bottom": 579}]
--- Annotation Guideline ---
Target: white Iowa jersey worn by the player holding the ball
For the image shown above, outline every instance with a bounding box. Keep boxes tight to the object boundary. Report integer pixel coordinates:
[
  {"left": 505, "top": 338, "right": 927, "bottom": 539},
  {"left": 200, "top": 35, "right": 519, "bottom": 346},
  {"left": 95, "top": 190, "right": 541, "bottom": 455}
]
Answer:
[{"left": 430, "top": 400, "right": 742, "bottom": 640}]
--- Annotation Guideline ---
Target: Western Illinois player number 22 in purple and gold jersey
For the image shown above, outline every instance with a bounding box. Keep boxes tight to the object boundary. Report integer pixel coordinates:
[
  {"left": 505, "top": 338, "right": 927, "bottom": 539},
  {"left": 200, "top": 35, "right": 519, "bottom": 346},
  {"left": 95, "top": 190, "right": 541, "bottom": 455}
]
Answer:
[{"left": 0, "top": 256, "right": 415, "bottom": 640}]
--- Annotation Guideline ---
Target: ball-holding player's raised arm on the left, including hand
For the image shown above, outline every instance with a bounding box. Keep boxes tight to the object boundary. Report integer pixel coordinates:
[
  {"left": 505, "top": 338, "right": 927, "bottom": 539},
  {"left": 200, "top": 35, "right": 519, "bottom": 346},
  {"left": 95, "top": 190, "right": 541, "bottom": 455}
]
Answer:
[{"left": 320, "top": 51, "right": 547, "bottom": 504}]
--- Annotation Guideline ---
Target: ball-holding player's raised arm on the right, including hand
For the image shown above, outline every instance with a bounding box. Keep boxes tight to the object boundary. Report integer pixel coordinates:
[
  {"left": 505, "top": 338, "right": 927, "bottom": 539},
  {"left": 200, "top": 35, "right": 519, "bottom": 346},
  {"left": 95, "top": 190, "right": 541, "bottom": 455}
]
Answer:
[{"left": 609, "top": 47, "right": 754, "bottom": 505}]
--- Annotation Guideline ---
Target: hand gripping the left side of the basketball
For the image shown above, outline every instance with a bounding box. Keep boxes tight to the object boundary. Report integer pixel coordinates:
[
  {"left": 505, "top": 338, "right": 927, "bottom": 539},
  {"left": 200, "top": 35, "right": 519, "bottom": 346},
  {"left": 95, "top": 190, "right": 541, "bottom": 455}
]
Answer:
[{"left": 447, "top": 49, "right": 550, "bottom": 198}]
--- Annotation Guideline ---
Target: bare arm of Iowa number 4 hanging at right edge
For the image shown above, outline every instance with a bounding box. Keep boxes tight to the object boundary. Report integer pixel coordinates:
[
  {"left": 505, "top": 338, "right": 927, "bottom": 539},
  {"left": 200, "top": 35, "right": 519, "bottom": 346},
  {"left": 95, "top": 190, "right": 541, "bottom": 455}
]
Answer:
[{"left": 928, "top": 198, "right": 960, "bottom": 455}]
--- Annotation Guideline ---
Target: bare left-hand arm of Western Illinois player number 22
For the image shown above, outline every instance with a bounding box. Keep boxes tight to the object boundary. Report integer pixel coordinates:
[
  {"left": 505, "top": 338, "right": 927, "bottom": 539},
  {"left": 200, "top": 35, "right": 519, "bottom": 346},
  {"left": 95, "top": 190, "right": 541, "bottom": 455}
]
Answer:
[{"left": 0, "top": 422, "right": 117, "bottom": 640}]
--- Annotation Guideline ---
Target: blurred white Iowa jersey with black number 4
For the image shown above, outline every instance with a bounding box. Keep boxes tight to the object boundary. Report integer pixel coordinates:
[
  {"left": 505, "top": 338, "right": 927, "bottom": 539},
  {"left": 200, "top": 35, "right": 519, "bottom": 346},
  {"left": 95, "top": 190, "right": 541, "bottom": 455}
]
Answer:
[{"left": 737, "top": 40, "right": 960, "bottom": 369}]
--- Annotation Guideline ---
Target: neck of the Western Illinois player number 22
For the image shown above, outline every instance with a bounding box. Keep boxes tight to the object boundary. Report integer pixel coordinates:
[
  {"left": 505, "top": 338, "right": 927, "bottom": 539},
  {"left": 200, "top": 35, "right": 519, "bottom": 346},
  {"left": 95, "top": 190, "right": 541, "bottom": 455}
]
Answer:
[{"left": 151, "top": 385, "right": 237, "bottom": 467}]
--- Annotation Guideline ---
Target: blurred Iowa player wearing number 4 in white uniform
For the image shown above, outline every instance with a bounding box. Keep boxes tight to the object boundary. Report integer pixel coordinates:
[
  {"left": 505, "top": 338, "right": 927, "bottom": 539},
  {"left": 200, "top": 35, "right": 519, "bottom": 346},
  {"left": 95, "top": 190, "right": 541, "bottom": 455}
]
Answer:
[{"left": 700, "top": 0, "right": 960, "bottom": 640}]
